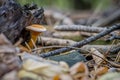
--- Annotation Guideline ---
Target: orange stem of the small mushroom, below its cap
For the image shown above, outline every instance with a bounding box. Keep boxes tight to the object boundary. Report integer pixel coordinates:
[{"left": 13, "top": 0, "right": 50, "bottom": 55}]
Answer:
[{"left": 28, "top": 31, "right": 40, "bottom": 49}]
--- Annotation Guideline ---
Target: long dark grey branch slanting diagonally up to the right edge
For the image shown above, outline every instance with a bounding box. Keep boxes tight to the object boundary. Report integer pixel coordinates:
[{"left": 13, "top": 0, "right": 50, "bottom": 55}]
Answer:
[{"left": 40, "top": 24, "right": 120, "bottom": 57}]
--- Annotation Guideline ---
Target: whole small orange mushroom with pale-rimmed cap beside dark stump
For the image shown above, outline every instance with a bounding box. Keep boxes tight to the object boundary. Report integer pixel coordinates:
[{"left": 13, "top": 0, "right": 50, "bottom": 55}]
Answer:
[{"left": 26, "top": 24, "right": 46, "bottom": 48}]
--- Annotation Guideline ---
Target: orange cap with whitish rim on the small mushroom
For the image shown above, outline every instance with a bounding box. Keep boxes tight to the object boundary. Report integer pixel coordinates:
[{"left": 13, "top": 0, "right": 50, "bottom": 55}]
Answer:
[{"left": 26, "top": 24, "right": 46, "bottom": 32}]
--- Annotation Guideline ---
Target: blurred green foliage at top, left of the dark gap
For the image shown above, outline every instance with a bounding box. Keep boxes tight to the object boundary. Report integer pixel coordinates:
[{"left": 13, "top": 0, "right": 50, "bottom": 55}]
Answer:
[{"left": 17, "top": 0, "right": 73, "bottom": 10}]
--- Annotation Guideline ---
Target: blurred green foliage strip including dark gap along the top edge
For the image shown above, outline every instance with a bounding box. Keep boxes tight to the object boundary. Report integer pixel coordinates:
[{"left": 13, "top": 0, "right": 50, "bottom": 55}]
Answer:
[{"left": 18, "top": 0, "right": 111, "bottom": 10}]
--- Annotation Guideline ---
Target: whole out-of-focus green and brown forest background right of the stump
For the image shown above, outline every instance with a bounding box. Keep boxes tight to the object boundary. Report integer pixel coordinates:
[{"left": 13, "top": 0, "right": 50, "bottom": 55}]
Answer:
[{"left": 17, "top": 0, "right": 120, "bottom": 26}]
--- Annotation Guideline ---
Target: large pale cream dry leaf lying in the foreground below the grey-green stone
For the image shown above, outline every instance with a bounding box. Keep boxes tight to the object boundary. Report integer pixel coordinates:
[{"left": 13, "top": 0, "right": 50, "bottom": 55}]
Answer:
[{"left": 20, "top": 54, "right": 69, "bottom": 78}]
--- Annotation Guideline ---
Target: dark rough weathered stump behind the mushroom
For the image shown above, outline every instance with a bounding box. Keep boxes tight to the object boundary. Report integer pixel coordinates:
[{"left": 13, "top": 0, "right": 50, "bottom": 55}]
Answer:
[{"left": 0, "top": 0, "right": 44, "bottom": 43}]
